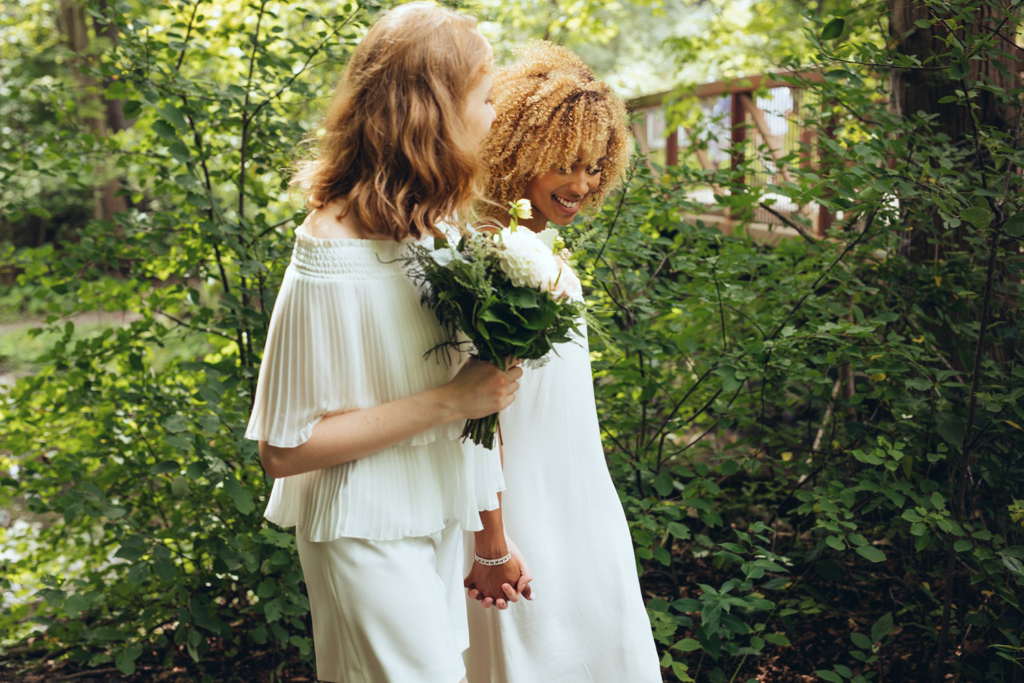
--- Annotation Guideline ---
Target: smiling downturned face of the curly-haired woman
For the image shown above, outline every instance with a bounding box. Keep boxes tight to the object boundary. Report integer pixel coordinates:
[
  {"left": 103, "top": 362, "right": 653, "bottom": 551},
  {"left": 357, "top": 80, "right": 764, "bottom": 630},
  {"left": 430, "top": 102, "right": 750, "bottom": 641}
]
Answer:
[{"left": 524, "top": 141, "right": 607, "bottom": 227}]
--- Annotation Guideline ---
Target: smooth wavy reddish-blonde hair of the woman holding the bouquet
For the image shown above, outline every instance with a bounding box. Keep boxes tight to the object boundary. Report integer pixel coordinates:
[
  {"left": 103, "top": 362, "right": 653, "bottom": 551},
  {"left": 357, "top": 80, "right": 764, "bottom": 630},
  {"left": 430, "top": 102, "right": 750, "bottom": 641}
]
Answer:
[{"left": 290, "top": 2, "right": 494, "bottom": 241}]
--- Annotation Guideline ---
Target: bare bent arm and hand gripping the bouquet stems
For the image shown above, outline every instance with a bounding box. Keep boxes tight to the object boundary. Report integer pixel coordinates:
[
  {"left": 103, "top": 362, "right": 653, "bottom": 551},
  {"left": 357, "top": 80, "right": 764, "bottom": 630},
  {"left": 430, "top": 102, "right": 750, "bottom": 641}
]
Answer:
[{"left": 259, "top": 358, "right": 522, "bottom": 479}]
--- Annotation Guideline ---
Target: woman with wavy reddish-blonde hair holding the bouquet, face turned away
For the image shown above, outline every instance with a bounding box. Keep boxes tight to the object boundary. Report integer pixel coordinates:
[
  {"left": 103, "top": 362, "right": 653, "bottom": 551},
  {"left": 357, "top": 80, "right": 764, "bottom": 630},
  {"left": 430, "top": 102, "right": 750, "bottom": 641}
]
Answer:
[{"left": 246, "top": 3, "right": 522, "bottom": 683}]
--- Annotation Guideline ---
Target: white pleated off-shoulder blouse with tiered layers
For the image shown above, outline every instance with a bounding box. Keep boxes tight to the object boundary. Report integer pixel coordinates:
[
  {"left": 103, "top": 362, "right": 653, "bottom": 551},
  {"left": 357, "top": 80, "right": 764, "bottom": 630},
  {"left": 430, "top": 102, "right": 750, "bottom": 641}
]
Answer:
[{"left": 246, "top": 225, "right": 505, "bottom": 542}]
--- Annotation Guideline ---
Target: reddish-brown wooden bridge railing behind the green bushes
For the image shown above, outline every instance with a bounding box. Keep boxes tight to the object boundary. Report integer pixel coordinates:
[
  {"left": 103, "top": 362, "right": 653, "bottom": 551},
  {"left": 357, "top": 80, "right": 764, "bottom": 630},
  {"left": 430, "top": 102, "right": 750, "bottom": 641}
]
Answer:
[{"left": 628, "top": 71, "right": 834, "bottom": 242}]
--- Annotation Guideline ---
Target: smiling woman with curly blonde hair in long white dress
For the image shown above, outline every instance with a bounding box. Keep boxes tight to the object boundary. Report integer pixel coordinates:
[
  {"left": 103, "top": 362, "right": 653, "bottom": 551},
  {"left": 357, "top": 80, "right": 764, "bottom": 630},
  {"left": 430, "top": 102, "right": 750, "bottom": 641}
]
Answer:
[{"left": 466, "top": 43, "right": 662, "bottom": 683}]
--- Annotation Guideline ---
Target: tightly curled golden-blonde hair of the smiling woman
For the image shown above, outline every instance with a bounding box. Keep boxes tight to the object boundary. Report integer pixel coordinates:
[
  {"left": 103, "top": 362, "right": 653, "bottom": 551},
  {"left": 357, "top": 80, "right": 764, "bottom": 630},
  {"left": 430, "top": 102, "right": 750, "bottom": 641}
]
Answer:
[{"left": 479, "top": 41, "right": 630, "bottom": 218}]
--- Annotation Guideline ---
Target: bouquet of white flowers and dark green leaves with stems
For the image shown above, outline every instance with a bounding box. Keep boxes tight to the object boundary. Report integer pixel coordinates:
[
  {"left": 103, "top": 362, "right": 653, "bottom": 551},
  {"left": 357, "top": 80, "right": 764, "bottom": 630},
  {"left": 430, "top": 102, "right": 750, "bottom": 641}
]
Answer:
[{"left": 410, "top": 200, "right": 585, "bottom": 449}]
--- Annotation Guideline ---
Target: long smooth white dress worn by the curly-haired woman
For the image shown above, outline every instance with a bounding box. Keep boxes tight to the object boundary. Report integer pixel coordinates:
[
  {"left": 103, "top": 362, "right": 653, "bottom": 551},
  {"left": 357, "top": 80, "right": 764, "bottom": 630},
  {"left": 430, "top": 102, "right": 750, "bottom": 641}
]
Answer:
[{"left": 465, "top": 317, "right": 662, "bottom": 683}]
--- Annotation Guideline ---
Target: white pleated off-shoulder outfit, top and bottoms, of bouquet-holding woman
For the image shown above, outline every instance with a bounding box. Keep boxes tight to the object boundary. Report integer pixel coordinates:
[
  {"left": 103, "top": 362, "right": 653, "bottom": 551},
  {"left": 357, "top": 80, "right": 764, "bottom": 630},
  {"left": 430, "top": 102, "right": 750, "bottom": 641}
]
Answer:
[{"left": 246, "top": 225, "right": 504, "bottom": 683}]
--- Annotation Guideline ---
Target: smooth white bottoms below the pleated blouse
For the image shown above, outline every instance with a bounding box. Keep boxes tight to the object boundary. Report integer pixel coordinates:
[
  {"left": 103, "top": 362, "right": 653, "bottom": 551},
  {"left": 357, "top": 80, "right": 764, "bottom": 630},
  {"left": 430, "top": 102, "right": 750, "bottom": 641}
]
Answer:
[{"left": 296, "top": 523, "right": 469, "bottom": 683}]
